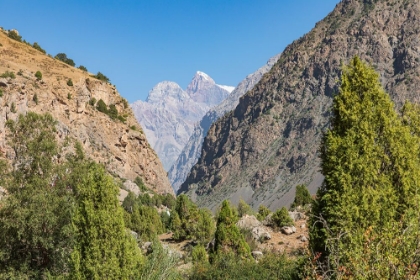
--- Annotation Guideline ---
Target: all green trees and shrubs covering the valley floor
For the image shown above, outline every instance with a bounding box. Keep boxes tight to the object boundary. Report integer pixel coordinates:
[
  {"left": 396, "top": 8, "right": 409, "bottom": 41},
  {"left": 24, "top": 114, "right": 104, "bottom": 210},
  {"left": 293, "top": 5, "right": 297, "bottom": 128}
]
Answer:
[{"left": 0, "top": 57, "right": 420, "bottom": 279}]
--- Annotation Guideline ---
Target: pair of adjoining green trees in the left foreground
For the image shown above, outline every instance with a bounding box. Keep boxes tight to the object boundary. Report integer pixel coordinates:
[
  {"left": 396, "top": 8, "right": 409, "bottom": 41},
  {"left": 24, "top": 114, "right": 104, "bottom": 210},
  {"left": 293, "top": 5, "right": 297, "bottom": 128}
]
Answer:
[{"left": 0, "top": 112, "right": 141, "bottom": 279}]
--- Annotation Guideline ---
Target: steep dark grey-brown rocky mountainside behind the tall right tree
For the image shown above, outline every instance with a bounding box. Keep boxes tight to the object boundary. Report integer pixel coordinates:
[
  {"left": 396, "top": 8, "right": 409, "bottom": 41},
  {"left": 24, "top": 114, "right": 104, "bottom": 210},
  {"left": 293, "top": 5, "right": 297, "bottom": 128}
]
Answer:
[{"left": 180, "top": 0, "right": 420, "bottom": 210}]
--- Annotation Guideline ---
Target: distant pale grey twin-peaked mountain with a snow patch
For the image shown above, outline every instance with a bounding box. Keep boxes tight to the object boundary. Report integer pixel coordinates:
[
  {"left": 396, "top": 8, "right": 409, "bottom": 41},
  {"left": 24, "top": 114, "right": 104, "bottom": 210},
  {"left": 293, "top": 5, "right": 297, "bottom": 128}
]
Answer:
[{"left": 131, "top": 71, "right": 233, "bottom": 170}]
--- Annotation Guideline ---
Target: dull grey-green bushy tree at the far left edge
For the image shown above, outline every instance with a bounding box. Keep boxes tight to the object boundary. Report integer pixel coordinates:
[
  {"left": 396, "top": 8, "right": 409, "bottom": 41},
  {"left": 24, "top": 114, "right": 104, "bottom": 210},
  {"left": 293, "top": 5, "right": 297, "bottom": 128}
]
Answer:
[{"left": 0, "top": 113, "right": 73, "bottom": 279}]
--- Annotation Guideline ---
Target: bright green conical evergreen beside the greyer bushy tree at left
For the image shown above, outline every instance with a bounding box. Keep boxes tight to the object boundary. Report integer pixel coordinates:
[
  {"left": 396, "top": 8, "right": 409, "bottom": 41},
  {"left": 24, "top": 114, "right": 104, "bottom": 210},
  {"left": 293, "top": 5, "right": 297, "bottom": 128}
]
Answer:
[{"left": 71, "top": 162, "right": 141, "bottom": 279}]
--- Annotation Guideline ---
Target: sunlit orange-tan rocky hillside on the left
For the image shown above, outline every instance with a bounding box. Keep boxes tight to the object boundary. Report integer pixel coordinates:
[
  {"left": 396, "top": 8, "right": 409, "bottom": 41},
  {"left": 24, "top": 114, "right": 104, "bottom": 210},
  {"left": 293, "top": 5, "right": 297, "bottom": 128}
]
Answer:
[{"left": 0, "top": 32, "right": 173, "bottom": 193}]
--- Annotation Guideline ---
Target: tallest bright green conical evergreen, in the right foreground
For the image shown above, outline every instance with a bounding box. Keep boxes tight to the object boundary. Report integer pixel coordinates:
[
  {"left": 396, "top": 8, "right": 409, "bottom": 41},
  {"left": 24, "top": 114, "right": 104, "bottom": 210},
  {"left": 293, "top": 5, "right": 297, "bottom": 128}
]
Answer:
[{"left": 310, "top": 57, "right": 420, "bottom": 279}]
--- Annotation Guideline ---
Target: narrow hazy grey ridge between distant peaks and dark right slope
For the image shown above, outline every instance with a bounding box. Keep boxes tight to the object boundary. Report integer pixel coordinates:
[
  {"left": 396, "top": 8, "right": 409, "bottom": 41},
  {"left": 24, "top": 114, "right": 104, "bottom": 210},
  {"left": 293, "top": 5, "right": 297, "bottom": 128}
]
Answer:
[{"left": 168, "top": 55, "right": 280, "bottom": 192}]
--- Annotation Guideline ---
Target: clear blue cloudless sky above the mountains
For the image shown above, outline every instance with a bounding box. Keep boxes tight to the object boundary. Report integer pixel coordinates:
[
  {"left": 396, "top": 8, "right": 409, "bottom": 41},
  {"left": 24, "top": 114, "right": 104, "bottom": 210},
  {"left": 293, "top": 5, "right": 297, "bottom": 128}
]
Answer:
[{"left": 0, "top": 0, "right": 339, "bottom": 103}]
